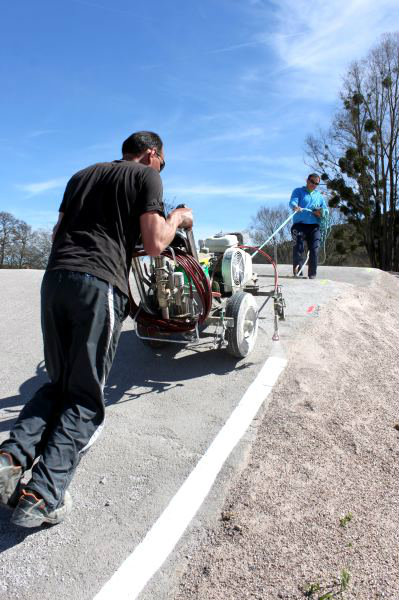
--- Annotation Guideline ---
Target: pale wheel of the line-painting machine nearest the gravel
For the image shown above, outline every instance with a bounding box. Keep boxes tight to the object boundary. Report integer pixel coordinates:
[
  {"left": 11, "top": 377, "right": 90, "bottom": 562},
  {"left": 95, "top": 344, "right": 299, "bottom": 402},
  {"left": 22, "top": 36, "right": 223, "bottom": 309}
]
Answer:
[{"left": 225, "top": 292, "right": 258, "bottom": 358}]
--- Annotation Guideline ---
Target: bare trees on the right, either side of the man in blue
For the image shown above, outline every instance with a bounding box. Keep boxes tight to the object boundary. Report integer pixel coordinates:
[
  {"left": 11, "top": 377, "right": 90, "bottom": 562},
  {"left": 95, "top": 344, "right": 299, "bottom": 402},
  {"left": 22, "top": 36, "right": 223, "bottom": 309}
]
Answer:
[{"left": 250, "top": 33, "right": 399, "bottom": 271}]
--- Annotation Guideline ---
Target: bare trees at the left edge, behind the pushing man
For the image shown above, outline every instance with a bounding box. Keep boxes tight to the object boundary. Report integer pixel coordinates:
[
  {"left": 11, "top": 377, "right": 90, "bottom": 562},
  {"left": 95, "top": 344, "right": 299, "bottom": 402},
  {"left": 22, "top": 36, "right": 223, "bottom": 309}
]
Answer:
[{"left": 0, "top": 212, "right": 51, "bottom": 269}]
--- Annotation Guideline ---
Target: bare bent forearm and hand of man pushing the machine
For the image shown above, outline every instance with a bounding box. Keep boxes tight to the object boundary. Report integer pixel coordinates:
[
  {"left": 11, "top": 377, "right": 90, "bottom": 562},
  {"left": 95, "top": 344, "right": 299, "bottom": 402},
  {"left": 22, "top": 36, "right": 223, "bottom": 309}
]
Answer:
[{"left": 140, "top": 208, "right": 193, "bottom": 256}]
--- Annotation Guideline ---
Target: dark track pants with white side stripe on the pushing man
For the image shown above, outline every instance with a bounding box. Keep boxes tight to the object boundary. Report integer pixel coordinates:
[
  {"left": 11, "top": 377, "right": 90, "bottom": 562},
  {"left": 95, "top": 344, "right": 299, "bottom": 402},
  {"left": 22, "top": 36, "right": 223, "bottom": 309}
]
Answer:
[{"left": 1, "top": 270, "right": 128, "bottom": 510}]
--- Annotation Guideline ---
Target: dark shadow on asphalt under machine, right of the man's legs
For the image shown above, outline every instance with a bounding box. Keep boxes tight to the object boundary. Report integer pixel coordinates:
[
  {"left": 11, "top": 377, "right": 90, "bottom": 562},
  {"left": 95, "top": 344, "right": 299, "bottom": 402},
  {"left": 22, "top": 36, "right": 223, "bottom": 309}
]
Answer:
[{"left": 104, "top": 330, "right": 253, "bottom": 406}]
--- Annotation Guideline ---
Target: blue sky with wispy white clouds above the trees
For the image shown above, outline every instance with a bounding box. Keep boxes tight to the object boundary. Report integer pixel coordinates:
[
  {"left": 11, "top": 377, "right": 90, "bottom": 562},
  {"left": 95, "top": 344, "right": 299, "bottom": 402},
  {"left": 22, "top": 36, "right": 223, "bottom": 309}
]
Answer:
[{"left": 0, "top": 0, "right": 398, "bottom": 239}]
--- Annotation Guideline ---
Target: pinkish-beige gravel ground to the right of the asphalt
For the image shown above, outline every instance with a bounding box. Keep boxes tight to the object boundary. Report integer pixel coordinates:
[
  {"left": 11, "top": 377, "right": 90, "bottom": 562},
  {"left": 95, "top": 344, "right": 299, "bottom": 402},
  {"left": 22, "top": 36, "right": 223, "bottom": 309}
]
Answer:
[{"left": 173, "top": 272, "right": 399, "bottom": 600}]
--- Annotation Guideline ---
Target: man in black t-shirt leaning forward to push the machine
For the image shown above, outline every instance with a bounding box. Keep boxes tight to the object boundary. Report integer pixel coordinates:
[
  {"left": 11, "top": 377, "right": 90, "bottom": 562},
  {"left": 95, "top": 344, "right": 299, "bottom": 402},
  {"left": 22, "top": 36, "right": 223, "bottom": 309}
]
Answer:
[{"left": 0, "top": 131, "right": 193, "bottom": 527}]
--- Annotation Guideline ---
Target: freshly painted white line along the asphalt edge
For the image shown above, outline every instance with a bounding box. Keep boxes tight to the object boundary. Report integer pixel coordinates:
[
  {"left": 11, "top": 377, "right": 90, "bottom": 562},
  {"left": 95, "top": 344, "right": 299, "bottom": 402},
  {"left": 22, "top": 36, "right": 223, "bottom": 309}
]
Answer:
[{"left": 94, "top": 357, "right": 287, "bottom": 600}]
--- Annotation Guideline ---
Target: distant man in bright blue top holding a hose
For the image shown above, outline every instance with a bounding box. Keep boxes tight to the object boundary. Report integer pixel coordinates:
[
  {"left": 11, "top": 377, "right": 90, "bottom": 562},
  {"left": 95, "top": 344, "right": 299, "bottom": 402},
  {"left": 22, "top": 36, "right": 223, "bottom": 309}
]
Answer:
[{"left": 289, "top": 173, "right": 328, "bottom": 279}]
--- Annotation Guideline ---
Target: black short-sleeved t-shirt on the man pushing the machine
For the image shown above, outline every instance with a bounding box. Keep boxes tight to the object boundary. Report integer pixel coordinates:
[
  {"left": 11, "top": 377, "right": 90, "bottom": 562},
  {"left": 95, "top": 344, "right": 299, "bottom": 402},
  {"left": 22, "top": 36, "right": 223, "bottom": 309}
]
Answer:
[{"left": 47, "top": 160, "right": 164, "bottom": 295}]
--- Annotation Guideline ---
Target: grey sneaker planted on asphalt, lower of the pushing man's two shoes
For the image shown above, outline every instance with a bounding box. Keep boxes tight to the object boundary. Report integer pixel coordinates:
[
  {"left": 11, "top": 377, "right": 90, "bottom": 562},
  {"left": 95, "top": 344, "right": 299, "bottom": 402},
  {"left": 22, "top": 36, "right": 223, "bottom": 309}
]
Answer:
[{"left": 11, "top": 489, "right": 72, "bottom": 527}]
